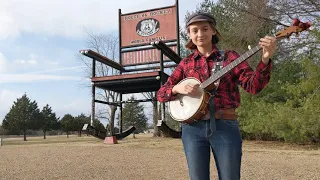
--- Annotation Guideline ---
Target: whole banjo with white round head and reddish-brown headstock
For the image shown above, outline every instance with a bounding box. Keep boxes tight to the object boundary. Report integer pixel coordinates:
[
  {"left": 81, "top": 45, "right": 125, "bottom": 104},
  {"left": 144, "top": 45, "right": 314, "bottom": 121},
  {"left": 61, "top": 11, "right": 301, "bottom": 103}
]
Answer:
[{"left": 168, "top": 19, "right": 310, "bottom": 123}]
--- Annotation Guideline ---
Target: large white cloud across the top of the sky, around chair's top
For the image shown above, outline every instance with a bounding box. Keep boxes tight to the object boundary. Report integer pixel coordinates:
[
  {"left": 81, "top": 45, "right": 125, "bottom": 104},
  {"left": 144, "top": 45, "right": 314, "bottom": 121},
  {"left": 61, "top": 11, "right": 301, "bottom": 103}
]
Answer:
[{"left": 0, "top": 0, "right": 202, "bottom": 39}]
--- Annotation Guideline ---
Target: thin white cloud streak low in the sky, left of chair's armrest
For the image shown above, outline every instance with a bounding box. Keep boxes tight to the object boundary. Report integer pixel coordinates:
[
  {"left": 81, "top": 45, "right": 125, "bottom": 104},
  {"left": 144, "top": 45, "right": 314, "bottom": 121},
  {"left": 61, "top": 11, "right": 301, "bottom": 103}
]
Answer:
[{"left": 0, "top": 74, "right": 87, "bottom": 84}]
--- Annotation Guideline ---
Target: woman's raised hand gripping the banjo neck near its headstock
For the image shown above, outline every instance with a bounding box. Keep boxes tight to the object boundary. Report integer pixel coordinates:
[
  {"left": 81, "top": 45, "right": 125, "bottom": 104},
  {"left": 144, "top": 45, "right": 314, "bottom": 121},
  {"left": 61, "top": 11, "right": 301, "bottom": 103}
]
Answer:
[{"left": 259, "top": 36, "right": 277, "bottom": 64}]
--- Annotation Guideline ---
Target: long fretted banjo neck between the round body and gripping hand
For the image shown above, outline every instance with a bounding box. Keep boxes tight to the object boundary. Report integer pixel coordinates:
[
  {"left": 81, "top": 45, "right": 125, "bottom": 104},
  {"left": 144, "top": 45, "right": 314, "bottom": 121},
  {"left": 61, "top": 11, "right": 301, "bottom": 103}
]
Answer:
[{"left": 200, "top": 46, "right": 261, "bottom": 90}]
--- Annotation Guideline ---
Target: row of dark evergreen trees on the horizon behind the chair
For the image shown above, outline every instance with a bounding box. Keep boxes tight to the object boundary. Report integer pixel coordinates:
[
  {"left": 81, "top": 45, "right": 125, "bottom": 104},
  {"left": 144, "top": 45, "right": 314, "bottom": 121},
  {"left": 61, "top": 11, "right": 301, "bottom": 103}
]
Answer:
[{"left": 0, "top": 94, "right": 148, "bottom": 141}]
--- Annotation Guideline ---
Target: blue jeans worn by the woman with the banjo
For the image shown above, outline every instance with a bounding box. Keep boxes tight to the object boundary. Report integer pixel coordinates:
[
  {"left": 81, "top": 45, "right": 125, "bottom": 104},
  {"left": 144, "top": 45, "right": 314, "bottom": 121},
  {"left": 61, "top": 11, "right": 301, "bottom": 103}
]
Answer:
[{"left": 182, "top": 120, "right": 242, "bottom": 180}]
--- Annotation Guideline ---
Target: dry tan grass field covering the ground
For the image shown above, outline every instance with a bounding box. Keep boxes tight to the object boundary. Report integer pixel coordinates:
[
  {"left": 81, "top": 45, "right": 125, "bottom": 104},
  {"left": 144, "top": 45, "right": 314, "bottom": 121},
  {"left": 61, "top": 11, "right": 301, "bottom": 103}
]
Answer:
[{"left": 0, "top": 134, "right": 320, "bottom": 180}]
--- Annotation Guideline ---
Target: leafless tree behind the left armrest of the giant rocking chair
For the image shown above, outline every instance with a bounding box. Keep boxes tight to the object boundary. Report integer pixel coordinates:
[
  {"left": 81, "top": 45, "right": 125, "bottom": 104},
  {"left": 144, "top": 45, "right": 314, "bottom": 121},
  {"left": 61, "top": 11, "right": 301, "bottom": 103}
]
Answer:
[{"left": 79, "top": 30, "right": 120, "bottom": 133}]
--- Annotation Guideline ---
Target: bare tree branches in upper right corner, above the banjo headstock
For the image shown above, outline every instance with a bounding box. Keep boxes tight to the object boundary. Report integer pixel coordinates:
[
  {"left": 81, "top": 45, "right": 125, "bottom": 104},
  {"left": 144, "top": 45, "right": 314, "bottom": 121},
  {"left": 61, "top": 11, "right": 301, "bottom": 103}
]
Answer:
[{"left": 220, "top": 0, "right": 320, "bottom": 59}]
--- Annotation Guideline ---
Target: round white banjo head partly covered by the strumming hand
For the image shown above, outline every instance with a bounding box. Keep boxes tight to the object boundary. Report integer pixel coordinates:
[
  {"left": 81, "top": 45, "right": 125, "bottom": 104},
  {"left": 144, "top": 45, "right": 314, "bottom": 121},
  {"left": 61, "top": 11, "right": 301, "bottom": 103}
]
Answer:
[{"left": 168, "top": 78, "right": 204, "bottom": 122}]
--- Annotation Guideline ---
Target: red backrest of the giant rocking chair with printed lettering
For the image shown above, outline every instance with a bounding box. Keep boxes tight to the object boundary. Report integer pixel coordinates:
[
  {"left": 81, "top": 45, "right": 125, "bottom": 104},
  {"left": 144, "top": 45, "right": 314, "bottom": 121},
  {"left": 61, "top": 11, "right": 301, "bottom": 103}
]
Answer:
[{"left": 119, "top": 1, "right": 180, "bottom": 67}]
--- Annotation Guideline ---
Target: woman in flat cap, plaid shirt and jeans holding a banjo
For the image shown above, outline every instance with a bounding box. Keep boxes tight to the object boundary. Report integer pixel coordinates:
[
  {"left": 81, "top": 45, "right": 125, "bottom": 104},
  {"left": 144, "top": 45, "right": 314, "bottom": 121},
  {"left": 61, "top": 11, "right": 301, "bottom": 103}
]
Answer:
[{"left": 157, "top": 12, "right": 277, "bottom": 180}]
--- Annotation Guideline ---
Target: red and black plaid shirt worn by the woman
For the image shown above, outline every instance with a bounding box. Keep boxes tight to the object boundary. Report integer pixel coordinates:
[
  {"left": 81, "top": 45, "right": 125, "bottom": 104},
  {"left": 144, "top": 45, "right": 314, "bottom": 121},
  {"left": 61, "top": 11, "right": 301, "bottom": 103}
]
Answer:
[{"left": 157, "top": 45, "right": 272, "bottom": 110}]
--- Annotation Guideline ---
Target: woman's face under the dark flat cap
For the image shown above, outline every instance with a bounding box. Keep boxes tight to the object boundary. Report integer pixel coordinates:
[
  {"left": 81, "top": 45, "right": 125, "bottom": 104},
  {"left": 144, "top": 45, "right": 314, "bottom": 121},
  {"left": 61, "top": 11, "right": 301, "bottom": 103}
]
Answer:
[{"left": 188, "top": 22, "right": 216, "bottom": 47}]
